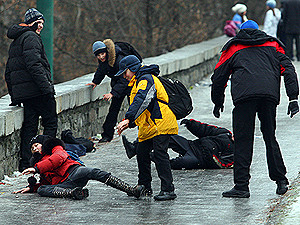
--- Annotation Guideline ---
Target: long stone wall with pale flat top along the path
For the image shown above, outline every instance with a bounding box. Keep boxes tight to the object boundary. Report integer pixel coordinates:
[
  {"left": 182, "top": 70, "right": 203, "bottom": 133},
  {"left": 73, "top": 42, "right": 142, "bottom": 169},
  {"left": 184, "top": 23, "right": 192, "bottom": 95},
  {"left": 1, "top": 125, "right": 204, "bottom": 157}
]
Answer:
[{"left": 0, "top": 36, "right": 228, "bottom": 179}]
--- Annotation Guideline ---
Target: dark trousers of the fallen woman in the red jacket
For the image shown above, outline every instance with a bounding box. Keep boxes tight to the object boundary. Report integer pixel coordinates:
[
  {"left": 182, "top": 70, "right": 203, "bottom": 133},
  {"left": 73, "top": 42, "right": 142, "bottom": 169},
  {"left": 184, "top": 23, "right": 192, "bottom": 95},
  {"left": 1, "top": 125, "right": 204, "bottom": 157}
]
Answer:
[{"left": 37, "top": 166, "right": 110, "bottom": 197}]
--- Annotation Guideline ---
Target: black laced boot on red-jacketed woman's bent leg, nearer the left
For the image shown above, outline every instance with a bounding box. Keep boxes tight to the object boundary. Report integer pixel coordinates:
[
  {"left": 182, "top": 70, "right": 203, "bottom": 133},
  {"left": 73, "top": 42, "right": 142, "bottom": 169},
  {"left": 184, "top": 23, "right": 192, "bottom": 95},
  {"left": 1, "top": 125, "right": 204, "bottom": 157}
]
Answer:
[{"left": 53, "top": 187, "right": 89, "bottom": 200}]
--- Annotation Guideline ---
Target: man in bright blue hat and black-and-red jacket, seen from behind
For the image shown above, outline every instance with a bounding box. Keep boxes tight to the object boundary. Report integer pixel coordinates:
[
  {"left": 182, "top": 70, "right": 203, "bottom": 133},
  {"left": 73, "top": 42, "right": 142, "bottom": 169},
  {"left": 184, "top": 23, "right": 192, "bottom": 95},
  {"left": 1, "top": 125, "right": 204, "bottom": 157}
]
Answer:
[{"left": 211, "top": 20, "right": 299, "bottom": 198}]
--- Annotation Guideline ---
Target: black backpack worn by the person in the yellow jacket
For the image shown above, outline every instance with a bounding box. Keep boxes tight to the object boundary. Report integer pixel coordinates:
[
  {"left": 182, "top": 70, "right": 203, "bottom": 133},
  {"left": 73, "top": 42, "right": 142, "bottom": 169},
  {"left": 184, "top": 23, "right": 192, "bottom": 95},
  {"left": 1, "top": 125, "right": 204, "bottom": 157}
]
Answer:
[{"left": 157, "top": 76, "right": 193, "bottom": 120}]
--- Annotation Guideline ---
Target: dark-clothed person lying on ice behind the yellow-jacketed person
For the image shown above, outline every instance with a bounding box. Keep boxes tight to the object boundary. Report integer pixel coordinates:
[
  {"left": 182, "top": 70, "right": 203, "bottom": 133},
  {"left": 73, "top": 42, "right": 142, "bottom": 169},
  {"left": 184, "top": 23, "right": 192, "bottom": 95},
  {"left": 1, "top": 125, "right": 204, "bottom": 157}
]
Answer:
[{"left": 122, "top": 119, "right": 234, "bottom": 170}]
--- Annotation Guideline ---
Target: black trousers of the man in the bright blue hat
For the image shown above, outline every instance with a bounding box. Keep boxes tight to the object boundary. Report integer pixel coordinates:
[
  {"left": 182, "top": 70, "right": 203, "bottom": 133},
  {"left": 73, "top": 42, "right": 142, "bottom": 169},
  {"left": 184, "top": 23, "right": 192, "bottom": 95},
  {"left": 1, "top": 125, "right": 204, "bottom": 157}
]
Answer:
[{"left": 233, "top": 99, "right": 287, "bottom": 191}]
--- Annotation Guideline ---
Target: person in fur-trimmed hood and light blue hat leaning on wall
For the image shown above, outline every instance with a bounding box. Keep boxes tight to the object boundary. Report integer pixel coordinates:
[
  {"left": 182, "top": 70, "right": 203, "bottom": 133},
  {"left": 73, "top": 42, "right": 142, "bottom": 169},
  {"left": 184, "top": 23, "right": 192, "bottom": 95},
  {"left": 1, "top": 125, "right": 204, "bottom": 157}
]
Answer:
[{"left": 87, "top": 39, "right": 139, "bottom": 143}]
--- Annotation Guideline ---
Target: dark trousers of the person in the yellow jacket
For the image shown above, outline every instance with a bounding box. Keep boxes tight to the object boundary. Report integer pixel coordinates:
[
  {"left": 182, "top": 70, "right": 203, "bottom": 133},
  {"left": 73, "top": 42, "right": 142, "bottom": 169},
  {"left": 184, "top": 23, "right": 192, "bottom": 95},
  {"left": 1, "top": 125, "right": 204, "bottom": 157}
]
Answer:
[{"left": 137, "top": 135, "right": 174, "bottom": 191}]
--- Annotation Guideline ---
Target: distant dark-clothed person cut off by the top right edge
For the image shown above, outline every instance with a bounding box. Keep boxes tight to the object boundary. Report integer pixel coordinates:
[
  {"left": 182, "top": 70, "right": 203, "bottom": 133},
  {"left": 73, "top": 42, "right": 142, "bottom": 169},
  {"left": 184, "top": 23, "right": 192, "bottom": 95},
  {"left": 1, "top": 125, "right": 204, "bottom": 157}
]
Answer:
[{"left": 282, "top": 0, "right": 300, "bottom": 61}]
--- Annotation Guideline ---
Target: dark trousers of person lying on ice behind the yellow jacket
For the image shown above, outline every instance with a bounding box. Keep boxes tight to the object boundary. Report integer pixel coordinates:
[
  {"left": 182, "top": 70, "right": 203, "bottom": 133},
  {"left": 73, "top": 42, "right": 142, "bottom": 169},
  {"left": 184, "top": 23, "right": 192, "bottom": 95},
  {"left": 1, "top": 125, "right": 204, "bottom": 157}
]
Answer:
[{"left": 169, "top": 135, "right": 204, "bottom": 170}]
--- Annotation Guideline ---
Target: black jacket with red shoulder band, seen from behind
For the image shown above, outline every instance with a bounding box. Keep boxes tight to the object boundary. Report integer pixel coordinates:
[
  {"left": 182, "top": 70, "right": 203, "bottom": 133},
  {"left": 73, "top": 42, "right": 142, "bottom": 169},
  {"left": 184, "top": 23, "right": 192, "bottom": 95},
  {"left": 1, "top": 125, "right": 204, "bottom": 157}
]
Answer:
[{"left": 211, "top": 29, "right": 299, "bottom": 106}]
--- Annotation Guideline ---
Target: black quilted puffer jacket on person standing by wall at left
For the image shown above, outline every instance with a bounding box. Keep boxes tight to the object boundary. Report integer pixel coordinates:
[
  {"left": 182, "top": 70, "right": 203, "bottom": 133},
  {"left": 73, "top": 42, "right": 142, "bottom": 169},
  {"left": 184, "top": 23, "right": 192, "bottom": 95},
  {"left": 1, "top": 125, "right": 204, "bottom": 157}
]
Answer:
[{"left": 5, "top": 24, "right": 55, "bottom": 105}]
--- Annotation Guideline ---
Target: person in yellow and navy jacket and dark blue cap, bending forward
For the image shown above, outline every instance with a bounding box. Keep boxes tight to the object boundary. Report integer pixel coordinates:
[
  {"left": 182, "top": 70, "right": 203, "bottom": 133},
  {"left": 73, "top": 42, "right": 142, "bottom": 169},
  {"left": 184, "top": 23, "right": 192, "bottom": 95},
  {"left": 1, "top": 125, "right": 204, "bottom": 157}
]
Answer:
[{"left": 116, "top": 55, "right": 178, "bottom": 201}]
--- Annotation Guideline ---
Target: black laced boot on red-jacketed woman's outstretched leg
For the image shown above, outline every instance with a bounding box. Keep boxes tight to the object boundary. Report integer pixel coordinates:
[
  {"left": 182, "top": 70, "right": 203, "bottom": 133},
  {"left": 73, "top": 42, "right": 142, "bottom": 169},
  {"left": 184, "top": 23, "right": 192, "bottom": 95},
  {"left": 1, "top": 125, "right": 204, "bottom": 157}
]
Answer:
[{"left": 105, "top": 175, "right": 145, "bottom": 198}]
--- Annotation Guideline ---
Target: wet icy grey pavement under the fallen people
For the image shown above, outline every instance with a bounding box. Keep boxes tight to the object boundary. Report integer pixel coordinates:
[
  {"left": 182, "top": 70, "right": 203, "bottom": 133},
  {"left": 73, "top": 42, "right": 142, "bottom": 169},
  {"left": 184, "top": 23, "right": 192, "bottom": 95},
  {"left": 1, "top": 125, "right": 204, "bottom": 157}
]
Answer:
[{"left": 0, "top": 62, "right": 300, "bottom": 225}]
